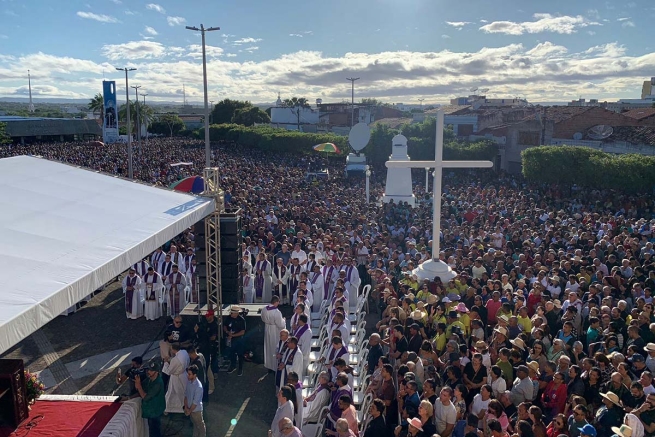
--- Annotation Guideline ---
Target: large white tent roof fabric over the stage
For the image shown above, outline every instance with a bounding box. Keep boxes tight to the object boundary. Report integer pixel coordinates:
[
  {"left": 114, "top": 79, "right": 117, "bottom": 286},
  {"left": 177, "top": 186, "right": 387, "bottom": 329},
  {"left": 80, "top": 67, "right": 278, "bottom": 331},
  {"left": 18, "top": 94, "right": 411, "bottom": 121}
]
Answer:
[{"left": 0, "top": 156, "right": 214, "bottom": 354}]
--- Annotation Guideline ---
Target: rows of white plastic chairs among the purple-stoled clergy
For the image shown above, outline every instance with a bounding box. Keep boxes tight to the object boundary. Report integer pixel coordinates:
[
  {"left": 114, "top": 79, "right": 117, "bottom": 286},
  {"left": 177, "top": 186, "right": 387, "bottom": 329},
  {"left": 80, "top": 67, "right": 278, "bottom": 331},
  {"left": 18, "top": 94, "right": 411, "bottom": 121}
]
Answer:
[{"left": 303, "top": 285, "right": 372, "bottom": 437}]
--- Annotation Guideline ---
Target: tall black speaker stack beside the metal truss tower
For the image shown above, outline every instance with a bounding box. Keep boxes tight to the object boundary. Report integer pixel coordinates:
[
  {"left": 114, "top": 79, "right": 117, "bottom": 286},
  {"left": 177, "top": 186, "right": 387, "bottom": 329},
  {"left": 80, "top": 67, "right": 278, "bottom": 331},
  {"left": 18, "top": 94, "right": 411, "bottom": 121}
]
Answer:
[{"left": 221, "top": 209, "right": 243, "bottom": 305}]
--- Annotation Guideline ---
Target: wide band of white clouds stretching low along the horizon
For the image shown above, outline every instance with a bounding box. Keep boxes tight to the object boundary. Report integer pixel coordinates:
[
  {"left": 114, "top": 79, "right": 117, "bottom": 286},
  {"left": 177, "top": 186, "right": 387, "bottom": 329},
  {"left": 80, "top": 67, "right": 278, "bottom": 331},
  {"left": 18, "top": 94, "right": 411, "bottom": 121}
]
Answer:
[{"left": 0, "top": 41, "right": 655, "bottom": 103}]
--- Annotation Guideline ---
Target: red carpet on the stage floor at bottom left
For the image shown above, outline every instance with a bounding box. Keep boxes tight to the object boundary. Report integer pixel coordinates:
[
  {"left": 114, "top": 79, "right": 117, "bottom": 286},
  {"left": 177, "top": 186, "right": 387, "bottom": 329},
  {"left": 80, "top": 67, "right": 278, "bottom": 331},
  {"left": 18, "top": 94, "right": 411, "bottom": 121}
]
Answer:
[{"left": 0, "top": 401, "right": 121, "bottom": 437}]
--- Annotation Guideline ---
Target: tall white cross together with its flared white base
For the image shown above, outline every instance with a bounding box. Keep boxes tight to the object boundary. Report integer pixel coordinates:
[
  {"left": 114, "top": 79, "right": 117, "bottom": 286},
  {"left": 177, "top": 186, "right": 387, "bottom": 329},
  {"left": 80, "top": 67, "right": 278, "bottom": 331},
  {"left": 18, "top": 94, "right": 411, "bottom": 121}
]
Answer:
[{"left": 387, "top": 110, "right": 494, "bottom": 282}]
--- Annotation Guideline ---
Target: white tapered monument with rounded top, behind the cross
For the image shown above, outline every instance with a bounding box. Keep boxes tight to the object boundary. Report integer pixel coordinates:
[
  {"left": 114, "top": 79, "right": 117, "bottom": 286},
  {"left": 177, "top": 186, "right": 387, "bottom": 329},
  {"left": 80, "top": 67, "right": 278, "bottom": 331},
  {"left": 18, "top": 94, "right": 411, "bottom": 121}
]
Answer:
[{"left": 382, "top": 135, "right": 416, "bottom": 206}]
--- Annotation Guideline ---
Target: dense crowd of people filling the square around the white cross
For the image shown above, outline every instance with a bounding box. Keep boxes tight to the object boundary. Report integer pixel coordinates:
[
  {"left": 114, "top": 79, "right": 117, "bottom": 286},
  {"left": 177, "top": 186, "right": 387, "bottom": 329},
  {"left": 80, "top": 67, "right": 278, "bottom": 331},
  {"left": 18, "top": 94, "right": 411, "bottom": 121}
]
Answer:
[{"left": 0, "top": 139, "right": 655, "bottom": 437}]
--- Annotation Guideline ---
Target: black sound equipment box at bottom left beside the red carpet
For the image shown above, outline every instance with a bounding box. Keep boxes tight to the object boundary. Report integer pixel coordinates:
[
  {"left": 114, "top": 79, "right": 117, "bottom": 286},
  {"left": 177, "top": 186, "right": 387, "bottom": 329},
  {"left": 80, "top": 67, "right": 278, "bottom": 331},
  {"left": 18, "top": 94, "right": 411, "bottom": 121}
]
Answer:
[{"left": 0, "top": 360, "right": 29, "bottom": 428}]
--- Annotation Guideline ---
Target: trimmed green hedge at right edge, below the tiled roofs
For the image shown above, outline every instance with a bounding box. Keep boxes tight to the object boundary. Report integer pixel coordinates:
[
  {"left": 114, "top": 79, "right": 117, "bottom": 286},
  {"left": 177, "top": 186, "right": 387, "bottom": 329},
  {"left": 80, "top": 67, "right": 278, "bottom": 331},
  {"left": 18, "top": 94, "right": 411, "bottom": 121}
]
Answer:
[{"left": 521, "top": 146, "right": 655, "bottom": 192}]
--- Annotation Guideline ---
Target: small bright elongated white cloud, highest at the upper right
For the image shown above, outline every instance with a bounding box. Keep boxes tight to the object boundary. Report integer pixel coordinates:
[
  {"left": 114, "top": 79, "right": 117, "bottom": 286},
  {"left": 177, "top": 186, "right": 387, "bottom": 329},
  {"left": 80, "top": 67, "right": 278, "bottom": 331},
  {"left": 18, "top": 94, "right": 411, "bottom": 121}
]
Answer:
[{"left": 480, "top": 14, "right": 600, "bottom": 35}]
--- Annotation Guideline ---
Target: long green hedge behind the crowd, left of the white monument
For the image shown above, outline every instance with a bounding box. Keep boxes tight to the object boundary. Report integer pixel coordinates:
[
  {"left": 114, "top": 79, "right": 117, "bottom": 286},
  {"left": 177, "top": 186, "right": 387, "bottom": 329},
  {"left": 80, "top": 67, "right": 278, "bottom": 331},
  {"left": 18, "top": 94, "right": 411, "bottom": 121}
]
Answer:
[{"left": 209, "top": 124, "right": 349, "bottom": 154}]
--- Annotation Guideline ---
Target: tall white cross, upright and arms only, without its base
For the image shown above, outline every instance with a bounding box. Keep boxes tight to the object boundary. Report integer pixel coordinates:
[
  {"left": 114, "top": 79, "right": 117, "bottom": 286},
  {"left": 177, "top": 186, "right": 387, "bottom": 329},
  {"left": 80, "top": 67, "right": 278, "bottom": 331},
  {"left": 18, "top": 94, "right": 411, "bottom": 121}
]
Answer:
[{"left": 386, "top": 110, "right": 494, "bottom": 262}]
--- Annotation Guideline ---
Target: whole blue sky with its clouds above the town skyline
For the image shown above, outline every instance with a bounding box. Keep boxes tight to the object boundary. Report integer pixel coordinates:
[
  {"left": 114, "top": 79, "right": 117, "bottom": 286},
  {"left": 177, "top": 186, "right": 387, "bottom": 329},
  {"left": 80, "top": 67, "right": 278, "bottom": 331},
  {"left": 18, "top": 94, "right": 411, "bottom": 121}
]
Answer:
[{"left": 0, "top": 0, "right": 655, "bottom": 103}]
